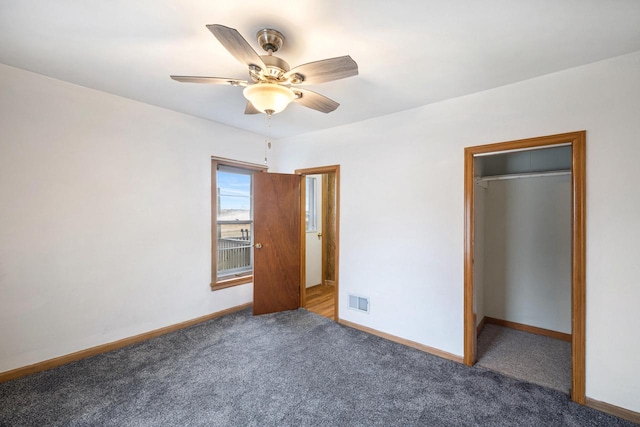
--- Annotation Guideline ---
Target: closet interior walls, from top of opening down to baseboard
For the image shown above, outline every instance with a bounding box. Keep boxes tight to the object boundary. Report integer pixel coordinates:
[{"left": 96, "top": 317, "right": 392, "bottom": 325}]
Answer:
[{"left": 474, "top": 147, "right": 571, "bottom": 334}]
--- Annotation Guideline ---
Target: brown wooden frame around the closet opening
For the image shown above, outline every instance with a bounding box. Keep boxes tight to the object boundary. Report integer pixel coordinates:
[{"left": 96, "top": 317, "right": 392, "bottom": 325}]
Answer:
[{"left": 464, "top": 131, "right": 586, "bottom": 405}]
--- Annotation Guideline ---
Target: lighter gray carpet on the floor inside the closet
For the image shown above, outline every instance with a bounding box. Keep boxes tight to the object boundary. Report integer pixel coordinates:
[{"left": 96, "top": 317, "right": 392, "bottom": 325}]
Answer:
[{"left": 478, "top": 325, "right": 571, "bottom": 394}]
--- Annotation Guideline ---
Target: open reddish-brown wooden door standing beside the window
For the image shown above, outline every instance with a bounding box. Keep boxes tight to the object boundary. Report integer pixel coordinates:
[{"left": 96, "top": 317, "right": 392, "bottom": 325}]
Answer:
[{"left": 253, "top": 173, "right": 302, "bottom": 315}]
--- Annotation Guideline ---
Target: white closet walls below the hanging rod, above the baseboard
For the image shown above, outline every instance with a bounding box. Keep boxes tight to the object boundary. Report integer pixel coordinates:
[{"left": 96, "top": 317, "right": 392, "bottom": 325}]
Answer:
[{"left": 476, "top": 175, "right": 571, "bottom": 334}]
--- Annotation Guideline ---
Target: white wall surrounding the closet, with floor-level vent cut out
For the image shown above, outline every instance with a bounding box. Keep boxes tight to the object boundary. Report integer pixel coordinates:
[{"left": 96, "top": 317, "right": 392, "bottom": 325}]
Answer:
[{"left": 274, "top": 52, "right": 640, "bottom": 411}]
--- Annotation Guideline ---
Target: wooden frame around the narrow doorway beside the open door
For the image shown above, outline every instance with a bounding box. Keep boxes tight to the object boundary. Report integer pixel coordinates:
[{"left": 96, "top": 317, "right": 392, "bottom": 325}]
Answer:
[{"left": 295, "top": 165, "right": 340, "bottom": 322}]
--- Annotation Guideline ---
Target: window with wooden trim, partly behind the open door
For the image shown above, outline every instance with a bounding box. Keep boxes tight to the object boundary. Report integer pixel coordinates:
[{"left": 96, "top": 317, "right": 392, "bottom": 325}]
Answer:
[{"left": 211, "top": 159, "right": 265, "bottom": 290}]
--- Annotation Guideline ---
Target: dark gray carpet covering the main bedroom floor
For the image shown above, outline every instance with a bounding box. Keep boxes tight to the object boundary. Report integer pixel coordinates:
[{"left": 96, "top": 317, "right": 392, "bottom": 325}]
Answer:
[{"left": 0, "top": 310, "right": 633, "bottom": 426}]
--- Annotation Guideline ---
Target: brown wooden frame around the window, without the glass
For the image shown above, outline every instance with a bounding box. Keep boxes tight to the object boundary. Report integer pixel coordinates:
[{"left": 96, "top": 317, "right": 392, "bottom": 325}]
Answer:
[{"left": 210, "top": 157, "right": 267, "bottom": 291}]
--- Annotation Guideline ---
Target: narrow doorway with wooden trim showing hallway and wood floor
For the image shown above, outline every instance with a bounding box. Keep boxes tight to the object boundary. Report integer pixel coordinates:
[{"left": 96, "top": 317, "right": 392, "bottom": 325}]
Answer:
[{"left": 296, "top": 165, "right": 340, "bottom": 320}]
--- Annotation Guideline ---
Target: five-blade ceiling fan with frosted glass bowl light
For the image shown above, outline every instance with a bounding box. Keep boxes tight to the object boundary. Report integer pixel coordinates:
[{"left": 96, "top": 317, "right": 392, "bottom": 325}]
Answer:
[{"left": 171, "top": 24, "right": 358, "bottom": 116}]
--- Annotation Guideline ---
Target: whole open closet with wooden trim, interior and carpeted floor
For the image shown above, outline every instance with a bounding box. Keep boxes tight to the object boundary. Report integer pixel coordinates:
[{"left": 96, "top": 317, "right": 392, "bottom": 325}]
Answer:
[{"left": 464, "top": 131, "right": 585, "bottom": 404}]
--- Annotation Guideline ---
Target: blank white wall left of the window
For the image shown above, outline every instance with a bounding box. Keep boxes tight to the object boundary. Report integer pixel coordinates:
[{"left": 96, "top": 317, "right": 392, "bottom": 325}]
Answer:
[{"left": 0, "top": 65, "right": 264, "bottom": 372}]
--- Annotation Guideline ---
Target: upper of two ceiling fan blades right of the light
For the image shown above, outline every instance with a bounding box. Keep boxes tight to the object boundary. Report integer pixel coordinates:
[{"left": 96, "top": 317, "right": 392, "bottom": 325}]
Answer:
[{"left": 284, "top": 55, "right": 358, "bottom": 85}]
